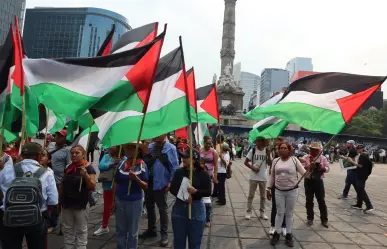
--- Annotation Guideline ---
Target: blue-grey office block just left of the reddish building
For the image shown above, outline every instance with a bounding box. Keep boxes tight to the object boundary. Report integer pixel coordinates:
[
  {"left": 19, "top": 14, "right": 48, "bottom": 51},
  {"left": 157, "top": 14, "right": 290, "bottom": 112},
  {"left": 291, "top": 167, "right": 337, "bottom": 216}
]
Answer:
[{"left": 259, "top": 68, "right": 289, "bottom": 104}]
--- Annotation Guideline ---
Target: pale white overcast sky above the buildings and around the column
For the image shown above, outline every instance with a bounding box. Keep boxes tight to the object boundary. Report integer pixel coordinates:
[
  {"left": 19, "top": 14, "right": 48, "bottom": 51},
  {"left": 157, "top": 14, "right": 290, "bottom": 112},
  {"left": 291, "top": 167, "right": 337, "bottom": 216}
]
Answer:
[{"left": 27, "top": 0, "right": 387, "bottom": 94}]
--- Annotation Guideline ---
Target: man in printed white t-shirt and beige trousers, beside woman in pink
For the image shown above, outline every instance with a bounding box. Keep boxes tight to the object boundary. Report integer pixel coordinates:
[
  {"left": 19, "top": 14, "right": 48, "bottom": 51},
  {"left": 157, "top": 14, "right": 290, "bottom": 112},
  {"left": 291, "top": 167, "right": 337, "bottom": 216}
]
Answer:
[{"left": 245, "top": 137, "right": 271, "bottom": 220}]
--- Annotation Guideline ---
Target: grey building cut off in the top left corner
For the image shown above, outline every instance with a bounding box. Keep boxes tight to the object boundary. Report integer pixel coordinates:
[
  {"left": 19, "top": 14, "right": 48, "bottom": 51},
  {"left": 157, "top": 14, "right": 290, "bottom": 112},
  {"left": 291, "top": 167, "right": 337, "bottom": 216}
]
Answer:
[{"left": 0, "top": 0, "right": 26, "bottom": 45}]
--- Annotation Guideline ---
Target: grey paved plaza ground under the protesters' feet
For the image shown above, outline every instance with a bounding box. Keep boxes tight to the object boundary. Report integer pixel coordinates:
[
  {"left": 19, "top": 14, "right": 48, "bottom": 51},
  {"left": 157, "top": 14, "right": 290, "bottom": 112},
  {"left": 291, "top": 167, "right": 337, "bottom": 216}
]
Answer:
[{"left": 49, "top": 160, "right": 387, "bottom": 249}]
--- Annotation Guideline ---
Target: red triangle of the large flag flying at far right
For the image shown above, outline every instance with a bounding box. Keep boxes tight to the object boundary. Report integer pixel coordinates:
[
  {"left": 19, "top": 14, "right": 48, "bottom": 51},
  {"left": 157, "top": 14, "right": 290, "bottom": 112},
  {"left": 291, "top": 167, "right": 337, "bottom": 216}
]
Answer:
[{"left": 336, "top": 84, "right": 381, "bottom": 123}]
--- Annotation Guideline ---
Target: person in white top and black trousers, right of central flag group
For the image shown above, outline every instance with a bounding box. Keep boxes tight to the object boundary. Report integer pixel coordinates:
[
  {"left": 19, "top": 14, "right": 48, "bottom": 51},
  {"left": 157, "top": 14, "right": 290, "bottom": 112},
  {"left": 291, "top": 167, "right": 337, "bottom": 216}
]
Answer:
[{"left": 212, "top": 143, "right": 230, "bottom": 206}]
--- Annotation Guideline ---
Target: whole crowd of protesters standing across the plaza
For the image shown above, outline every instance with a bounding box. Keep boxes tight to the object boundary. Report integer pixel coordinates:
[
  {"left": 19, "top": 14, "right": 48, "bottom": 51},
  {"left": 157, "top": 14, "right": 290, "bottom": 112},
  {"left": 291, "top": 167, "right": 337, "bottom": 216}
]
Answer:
[{"left": 0, "top": 130, "right": 374, "bottom": 249}]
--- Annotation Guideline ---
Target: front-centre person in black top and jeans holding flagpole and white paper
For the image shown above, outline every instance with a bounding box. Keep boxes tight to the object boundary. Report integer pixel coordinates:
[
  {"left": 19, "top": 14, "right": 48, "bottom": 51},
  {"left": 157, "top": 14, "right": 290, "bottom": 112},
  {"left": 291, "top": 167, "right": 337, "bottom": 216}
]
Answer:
[{"left": 171, "top": 150, "right": 211, "bottom": 249}]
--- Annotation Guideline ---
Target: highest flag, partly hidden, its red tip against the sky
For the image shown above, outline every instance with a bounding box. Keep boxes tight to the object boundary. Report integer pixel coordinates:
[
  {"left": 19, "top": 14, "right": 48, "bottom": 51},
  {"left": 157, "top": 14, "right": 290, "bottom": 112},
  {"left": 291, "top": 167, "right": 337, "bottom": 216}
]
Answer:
[{"left": 111, "top": 22, "right": 158, "bottom": 53}]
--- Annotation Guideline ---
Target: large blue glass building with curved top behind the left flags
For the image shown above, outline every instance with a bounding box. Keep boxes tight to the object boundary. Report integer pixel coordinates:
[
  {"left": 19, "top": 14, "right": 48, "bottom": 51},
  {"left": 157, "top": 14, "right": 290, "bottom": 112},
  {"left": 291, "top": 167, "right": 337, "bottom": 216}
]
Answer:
[{"left": 23, "top": 7, "right": 131, "bottom": 58}]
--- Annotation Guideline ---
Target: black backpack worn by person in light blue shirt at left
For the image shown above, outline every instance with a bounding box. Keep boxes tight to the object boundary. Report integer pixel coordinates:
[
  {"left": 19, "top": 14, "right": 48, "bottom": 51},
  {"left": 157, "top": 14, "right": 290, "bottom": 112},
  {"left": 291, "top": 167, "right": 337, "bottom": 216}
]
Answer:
[{"left": 4, "top": 163, "right": 47, "bottom": 227}]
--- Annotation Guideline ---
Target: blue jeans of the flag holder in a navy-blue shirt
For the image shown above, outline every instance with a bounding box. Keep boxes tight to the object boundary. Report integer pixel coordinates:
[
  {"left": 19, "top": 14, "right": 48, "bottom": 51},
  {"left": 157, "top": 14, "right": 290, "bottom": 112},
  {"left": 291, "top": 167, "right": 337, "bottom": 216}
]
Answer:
[{"left": 116, "top": 196, "right": 142, "bottom": 249}]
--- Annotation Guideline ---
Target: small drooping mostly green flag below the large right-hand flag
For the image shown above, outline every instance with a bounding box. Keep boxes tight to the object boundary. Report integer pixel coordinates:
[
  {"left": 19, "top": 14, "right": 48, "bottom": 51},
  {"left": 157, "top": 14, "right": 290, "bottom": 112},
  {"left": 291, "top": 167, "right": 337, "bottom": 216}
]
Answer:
[{"left": 249, "top": 117, "right": 289, "bottom": 142}]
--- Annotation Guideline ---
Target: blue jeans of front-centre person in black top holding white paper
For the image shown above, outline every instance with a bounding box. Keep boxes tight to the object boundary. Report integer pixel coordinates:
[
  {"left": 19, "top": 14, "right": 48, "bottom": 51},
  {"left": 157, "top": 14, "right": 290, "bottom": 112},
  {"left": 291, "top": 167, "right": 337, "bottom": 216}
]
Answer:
[{"left": 171, "top": 199, "right": 206, "bottom": 249}]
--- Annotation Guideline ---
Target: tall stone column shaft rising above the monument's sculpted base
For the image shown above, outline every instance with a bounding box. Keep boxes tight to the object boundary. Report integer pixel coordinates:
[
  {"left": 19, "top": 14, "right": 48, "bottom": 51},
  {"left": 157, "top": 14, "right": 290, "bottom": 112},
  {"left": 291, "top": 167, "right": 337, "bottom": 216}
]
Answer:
[{"left": 220, "top": 0, "right": 237, "bottom": 75}]
